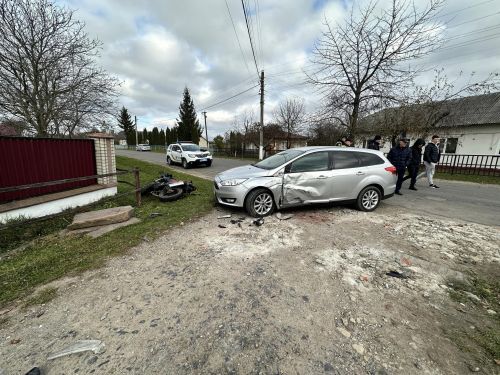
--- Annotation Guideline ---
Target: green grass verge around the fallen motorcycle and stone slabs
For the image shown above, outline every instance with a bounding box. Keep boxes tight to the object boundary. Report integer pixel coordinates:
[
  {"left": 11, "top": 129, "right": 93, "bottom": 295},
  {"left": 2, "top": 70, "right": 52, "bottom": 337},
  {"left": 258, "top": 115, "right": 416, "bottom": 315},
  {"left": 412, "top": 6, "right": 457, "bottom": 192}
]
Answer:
[{"left": 0, "top": 156, "right": 213, "bottom": 306}]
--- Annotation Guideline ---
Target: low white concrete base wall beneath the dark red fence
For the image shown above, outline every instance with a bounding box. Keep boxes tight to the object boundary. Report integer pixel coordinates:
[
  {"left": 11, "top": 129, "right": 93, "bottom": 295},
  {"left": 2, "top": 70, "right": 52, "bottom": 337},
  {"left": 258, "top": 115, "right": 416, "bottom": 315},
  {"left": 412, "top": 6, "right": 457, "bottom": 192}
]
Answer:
[{"left": 0, "top": 187, "right": 118, "bottom": 223}]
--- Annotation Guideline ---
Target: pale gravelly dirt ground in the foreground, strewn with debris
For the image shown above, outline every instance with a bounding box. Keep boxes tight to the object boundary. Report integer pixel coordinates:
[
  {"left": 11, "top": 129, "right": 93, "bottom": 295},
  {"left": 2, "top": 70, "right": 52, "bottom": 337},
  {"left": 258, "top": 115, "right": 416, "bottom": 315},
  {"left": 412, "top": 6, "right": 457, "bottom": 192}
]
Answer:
[{"left": 0, "top": 206, "right": 500, "bottom": 375}]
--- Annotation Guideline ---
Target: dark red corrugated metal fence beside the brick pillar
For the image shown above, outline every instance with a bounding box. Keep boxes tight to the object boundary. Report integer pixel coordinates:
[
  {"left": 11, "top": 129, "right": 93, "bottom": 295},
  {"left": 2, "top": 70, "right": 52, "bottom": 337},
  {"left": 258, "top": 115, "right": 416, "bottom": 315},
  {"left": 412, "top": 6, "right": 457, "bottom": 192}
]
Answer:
[{"left": 0, "top": 137, "right": 97, "bottom": 202}]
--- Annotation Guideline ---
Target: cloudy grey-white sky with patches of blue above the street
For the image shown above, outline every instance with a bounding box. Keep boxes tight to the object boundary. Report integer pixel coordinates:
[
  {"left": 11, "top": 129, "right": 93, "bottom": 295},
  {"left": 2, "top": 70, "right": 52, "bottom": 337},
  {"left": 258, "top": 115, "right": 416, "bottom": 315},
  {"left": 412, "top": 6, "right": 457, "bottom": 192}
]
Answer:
[{"left": 58, "top": 0, "right": 500, "bottom": 139}]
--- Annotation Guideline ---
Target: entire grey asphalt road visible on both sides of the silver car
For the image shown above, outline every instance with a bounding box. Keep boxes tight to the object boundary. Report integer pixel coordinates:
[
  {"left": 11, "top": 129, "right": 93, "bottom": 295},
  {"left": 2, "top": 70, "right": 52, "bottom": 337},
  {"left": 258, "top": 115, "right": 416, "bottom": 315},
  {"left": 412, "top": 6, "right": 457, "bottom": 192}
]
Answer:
[{"left": 116, "top": 150, "right": 500, "bottom": 226}]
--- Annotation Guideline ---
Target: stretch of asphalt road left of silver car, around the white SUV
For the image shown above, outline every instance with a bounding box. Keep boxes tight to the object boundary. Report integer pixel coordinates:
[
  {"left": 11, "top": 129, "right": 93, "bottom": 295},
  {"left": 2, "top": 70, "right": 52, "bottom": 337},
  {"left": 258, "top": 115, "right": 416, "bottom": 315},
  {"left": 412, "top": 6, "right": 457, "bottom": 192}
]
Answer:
[{"left": 116, "top": 150, "right": 252, "bottom": 180}]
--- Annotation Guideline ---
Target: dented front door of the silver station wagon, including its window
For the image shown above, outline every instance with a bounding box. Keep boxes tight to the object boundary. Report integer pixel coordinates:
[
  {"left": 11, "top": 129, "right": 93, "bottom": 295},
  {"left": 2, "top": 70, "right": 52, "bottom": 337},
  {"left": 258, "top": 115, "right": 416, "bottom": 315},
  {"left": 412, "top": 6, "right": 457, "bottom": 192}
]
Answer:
[{"left": 282, "top": 151, "right": 332, "bottom": 206}]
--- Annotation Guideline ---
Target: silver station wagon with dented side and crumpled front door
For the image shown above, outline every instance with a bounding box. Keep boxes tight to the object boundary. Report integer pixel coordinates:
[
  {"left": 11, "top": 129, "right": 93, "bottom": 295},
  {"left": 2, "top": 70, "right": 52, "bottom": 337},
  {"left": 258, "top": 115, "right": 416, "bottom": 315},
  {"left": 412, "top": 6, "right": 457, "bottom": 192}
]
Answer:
[{"left": 214, "top": 146, "right": 397, "bottom": 217}]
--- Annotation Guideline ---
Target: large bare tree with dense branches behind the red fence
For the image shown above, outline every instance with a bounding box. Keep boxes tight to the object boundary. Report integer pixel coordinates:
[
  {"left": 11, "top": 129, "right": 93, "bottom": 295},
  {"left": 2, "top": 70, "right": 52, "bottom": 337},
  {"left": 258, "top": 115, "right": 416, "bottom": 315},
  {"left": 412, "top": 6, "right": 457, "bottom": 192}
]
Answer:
[{"left": 0, "top": 0, "right": 117, "bottom": 136}]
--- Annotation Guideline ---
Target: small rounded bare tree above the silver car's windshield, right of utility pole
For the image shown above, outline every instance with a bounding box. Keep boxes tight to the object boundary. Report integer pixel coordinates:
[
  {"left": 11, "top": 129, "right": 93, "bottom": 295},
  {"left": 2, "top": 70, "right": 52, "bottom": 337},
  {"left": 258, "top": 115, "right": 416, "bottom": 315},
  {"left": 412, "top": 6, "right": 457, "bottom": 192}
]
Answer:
[{"left": 273, "top": 98, "right": 306, "bottom": 149}]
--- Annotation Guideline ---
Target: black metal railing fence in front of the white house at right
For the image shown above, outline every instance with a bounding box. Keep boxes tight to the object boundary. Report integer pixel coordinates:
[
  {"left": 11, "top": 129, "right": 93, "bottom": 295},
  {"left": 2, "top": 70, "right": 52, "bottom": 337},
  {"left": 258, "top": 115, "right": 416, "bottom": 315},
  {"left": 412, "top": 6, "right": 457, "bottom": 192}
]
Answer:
[{"left": 436, "top": 154, "right": 500, "bottom": 177}]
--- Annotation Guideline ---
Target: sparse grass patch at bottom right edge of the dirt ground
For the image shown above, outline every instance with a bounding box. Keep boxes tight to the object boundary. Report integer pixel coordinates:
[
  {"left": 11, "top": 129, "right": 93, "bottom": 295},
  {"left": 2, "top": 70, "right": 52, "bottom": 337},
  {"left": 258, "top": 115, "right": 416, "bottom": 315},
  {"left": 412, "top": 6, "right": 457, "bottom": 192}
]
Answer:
[{"left": 448, "top": 274, "right": 500, "bottom": 359}]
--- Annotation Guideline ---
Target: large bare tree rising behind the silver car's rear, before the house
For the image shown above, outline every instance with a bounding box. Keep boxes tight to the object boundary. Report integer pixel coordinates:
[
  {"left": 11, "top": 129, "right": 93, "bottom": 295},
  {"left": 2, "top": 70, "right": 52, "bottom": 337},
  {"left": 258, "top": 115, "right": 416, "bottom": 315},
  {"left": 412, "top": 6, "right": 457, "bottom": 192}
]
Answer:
[{"left": 308, "top": 0, "right": 444, "bottom": 138}]
